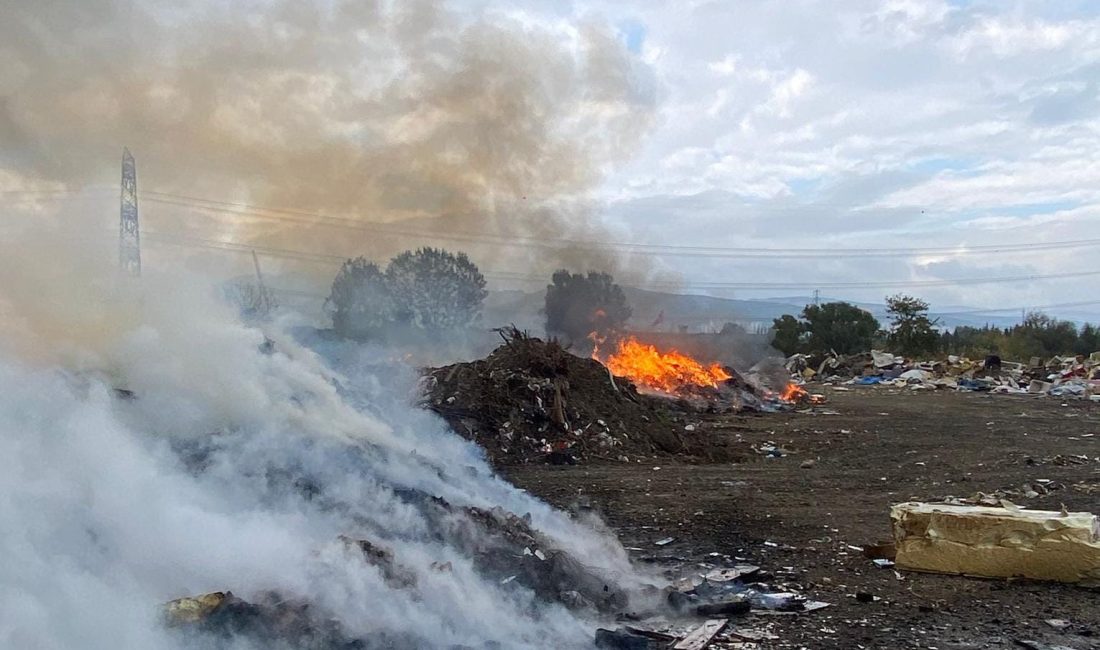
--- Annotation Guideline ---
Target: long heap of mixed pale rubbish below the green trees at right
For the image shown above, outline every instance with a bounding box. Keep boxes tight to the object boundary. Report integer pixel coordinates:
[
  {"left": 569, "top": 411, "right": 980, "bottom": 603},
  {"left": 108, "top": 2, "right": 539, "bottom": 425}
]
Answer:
[{"left": 787, "top": 350, "right": 1100, "bottom": 400}]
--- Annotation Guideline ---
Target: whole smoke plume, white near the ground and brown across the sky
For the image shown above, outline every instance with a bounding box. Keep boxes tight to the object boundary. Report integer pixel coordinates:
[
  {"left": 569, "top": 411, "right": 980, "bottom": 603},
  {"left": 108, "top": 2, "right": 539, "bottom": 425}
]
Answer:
[{"left": 0, "top": 7, "right": 668, "bottom": 650}]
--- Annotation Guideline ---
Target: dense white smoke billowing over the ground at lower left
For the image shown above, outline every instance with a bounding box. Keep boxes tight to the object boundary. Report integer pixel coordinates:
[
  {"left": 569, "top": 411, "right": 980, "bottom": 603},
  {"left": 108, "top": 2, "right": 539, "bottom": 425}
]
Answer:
[{"left": 0, "top": 226, "right": 646, "bottom": 650}]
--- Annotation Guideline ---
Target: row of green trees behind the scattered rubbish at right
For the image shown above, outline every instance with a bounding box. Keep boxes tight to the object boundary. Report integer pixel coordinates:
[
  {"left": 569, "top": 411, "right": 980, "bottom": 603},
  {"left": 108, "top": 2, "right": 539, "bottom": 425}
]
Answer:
[{"left": 772, "top": 295, "right": 1100, "bottom": 359}]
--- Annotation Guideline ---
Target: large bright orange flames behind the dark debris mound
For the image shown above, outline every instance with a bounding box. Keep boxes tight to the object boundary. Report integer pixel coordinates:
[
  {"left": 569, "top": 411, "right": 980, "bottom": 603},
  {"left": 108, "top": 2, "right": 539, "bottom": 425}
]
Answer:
[{"left": 592, "top": 337, "right": 730, "bottom": 395}]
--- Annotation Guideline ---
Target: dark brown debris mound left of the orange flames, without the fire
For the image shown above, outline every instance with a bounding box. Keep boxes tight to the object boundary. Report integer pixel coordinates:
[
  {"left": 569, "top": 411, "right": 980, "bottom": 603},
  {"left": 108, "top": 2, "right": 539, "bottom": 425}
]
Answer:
[{"left": 424, "top": 330, "right": 692, "bottom": 464}]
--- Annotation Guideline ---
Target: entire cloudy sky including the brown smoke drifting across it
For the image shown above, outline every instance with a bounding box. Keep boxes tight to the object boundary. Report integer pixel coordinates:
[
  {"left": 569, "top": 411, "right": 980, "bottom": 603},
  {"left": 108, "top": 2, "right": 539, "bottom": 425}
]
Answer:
[{"left": 0, "top": 0, "right": 1100, "bottom": 313}]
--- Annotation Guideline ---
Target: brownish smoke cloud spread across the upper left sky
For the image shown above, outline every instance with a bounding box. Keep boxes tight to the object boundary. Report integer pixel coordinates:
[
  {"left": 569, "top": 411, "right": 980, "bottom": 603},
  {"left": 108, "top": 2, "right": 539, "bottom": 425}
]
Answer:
[{"left": 0, "top": 0, "right": 655, "bottom": 277}]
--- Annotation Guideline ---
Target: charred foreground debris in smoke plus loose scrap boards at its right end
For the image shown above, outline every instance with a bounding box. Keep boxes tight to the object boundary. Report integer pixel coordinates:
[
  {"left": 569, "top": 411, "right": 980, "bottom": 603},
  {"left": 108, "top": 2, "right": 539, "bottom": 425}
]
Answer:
[{"left": 164, "top": 516, "right": 829, "bottom": 650}]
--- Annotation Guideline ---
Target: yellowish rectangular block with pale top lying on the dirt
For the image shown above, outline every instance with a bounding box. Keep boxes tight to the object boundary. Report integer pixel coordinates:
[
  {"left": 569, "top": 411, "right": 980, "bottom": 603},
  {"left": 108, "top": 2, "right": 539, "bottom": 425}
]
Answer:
[{"left": 890, "top": 503, "right": 1100, "bottom": 586}]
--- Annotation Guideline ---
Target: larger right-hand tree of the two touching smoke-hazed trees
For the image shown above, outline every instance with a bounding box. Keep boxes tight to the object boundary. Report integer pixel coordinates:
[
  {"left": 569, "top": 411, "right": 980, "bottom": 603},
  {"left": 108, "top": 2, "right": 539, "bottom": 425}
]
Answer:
[{"left": 386, "top": 247, "right": 488, "bottom": 331}]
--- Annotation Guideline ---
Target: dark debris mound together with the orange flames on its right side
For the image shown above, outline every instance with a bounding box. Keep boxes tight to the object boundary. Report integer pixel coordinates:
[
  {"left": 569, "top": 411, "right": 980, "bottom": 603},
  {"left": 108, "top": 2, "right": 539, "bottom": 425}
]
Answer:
[{"left": 422, "top": 329, "right": 796, "bottom": 464}]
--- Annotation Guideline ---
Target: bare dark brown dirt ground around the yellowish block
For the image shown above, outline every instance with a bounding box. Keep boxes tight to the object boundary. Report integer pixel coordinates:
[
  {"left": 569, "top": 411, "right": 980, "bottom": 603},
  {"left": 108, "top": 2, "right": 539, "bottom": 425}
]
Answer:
[{"left": 505, "top": 387, "right": 1100, "bottom": 650}]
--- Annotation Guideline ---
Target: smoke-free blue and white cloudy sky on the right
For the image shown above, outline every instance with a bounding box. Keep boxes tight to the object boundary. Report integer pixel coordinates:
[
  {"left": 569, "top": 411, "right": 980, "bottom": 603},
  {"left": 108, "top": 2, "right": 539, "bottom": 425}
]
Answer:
[{"left": 580, "top": 0, "right": 1100, "bottom": 314}]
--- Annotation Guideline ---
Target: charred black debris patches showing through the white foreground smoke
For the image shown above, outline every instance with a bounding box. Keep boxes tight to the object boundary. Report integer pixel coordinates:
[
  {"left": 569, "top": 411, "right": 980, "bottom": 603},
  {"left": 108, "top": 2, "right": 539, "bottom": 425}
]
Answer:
[{"left": 165, "top": 489, "right": 642, "bottom": 650}]
